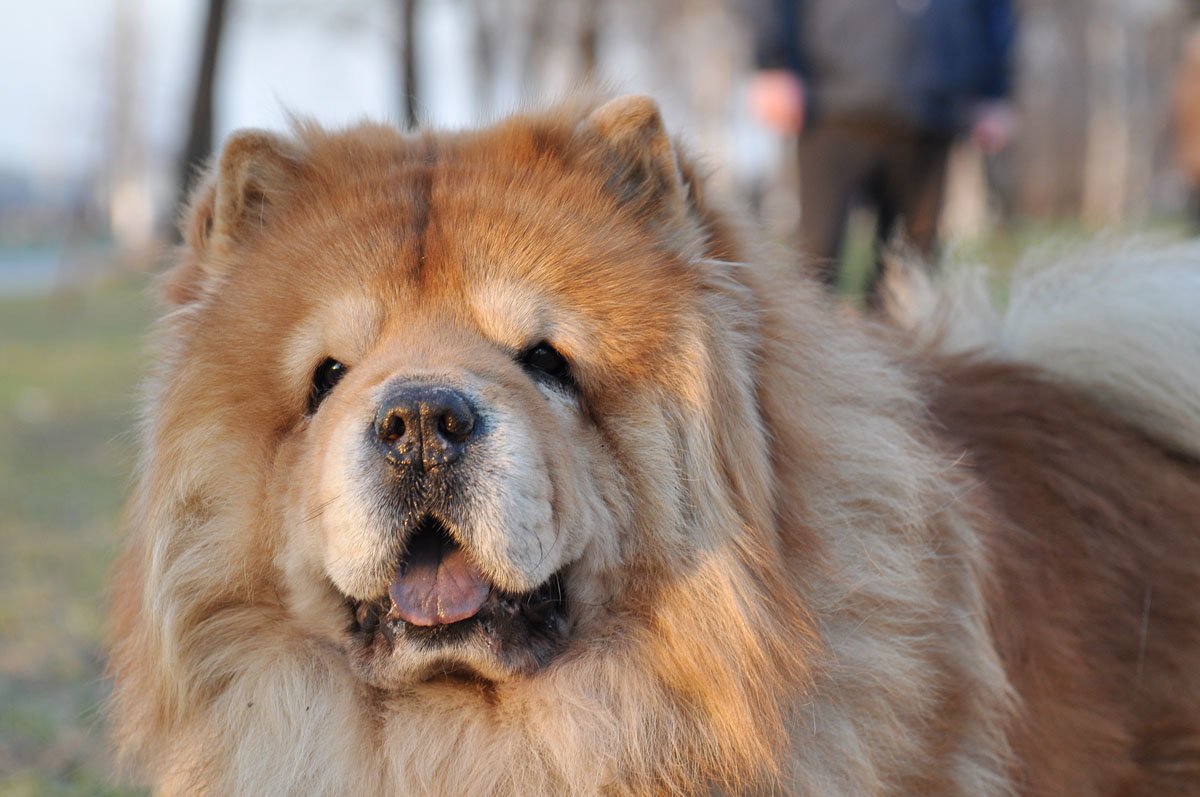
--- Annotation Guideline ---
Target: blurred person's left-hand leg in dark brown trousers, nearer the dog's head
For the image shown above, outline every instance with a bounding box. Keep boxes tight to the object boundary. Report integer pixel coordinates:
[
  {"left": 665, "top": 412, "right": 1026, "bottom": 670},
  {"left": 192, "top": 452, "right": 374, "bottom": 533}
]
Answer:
[{"left": 799, "top": 122, "right": 876, "bottom": 290}]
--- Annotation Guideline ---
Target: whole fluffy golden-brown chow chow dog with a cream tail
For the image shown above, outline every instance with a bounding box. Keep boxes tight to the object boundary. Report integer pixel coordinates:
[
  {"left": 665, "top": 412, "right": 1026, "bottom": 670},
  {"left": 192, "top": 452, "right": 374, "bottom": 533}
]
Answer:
[{"left": 110, "top": 96, "right": 1200, "bottom": 796}]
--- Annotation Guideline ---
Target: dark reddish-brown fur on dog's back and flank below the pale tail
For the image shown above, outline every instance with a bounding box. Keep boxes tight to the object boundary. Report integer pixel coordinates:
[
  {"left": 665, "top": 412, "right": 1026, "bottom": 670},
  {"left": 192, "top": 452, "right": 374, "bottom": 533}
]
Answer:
[{"left": 931, "top": 362, "right": 1200, "bottom": 795}]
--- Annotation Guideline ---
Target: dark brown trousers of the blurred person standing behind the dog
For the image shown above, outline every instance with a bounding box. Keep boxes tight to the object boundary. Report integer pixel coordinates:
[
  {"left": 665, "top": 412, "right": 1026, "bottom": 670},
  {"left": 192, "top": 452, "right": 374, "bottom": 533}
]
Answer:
[{"left": 799, "top": 119, "right": 953, "bottom": 304}]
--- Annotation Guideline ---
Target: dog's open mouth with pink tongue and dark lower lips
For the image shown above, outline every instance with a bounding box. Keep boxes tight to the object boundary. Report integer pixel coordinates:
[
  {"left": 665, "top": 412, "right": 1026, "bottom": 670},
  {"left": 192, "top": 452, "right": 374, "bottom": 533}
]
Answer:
[{"left": 350, "top": 516, "right": 568, "bottom": 672}]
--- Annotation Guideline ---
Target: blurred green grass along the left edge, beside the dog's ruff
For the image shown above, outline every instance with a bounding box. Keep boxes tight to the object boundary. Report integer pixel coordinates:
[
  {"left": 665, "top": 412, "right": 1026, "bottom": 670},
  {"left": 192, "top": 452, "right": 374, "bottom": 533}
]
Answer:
[{"left": 0, "top": 276, "right": 150, "bottom": 795}]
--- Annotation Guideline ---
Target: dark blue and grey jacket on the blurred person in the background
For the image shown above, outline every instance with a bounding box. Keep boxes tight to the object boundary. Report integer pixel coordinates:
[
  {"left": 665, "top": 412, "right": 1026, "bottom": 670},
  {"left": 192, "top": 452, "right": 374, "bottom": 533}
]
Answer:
[{"left": 751, "top": 0, "right": 1015, "bottom": 132}]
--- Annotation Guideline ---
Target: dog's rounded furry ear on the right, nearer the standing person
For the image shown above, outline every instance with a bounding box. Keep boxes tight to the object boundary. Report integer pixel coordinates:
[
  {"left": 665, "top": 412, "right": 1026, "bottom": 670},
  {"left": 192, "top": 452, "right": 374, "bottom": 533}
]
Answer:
[{"left": 575, "top": 95, "right": 688, "bottom": 215}]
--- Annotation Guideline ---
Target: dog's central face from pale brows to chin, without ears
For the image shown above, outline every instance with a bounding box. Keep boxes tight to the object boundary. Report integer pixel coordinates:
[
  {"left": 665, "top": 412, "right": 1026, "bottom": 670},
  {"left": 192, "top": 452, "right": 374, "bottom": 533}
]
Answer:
[{"left": 280, "top": 234, "right": 631, "bottom": 685}]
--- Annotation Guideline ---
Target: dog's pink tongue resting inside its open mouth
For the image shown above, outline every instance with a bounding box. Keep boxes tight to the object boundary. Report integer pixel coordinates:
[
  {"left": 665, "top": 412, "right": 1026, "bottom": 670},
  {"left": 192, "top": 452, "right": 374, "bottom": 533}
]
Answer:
[{"left": 388, "top": 537, "right": 490, "bottom": 625}]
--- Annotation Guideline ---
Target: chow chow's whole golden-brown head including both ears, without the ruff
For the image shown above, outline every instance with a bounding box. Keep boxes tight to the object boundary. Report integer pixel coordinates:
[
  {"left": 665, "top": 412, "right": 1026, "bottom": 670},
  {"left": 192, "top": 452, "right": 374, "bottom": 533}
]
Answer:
[{"left": 158, "top": 101, "right": 742, "bottom": 688}]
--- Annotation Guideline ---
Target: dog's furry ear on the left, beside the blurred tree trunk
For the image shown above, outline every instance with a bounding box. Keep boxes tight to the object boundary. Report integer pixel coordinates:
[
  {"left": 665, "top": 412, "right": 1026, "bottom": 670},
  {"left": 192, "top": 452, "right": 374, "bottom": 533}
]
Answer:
[{"left": 163, "top": 130, "right": 304, "bottom": 305}]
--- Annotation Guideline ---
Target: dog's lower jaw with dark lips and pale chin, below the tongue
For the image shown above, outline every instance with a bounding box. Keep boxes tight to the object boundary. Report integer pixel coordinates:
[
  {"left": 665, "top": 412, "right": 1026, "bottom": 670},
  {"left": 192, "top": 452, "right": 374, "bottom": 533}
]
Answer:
[{"left": 331, "top": 520, "right": 570, "bottom": 689}]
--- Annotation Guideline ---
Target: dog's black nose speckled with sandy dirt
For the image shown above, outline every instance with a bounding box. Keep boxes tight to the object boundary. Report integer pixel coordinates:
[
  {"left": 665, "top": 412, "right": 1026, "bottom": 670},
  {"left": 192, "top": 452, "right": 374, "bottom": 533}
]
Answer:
[{"left": 374, "top": 384, "right": 478, "bottom": 471}]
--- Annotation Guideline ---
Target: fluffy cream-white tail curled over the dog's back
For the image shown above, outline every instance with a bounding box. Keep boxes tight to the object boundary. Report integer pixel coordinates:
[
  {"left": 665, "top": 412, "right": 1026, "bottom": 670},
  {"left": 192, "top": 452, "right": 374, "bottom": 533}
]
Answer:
[{"left": 889, "top": 239, "right": 1200, "bottom": 456}]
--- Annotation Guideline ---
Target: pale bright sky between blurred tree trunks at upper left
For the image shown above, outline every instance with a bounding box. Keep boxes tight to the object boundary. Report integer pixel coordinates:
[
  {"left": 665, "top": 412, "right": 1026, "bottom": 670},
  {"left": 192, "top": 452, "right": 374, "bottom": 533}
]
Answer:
[{"left": 0, "top": 0, "right": 472, "bottom": 176}]
